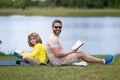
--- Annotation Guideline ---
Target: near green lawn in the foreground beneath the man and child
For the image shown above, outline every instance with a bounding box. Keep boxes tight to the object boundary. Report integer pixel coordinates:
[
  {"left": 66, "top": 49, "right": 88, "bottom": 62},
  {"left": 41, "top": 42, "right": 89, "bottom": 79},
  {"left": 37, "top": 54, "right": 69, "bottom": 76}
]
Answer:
[{"left": 0, "top": 55, "right": 120, "bottom": 80}]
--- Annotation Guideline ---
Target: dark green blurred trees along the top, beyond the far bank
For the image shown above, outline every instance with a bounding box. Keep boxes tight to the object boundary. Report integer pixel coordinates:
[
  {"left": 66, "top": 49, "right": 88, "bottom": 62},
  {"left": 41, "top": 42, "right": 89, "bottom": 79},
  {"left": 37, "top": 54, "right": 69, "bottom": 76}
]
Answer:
[{"left": 0, "top": 0, "right": 120, "bottom": 9}]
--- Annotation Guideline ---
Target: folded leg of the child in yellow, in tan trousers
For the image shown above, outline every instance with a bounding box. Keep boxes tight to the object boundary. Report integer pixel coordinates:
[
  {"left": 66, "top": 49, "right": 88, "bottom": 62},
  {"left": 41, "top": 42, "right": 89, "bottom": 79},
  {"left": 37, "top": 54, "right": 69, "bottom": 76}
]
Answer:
[{"left": 23, "top": 56, "right": 40, "bottom": 65}]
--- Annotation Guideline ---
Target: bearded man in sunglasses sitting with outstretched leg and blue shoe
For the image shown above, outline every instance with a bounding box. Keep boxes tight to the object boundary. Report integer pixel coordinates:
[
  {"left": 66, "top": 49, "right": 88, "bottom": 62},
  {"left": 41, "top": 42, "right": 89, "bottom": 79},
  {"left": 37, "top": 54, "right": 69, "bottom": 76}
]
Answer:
[{"left": 46, "top": 20, "right": 114, "bottom": 65}]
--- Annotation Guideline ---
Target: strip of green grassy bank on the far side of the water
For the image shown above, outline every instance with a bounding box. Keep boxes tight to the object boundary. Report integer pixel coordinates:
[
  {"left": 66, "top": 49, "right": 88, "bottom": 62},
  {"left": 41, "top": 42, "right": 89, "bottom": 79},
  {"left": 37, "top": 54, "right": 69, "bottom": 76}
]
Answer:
[{"left": 0, "top": 8, "right": 120, "bottom": 16}]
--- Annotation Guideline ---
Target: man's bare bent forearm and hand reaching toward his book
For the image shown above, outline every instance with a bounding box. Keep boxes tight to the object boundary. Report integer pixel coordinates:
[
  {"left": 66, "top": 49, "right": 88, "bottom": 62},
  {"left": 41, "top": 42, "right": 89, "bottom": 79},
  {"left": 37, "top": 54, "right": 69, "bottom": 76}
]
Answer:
[{"left": 51, "top": 47, "right": 76, "bottom": 57}]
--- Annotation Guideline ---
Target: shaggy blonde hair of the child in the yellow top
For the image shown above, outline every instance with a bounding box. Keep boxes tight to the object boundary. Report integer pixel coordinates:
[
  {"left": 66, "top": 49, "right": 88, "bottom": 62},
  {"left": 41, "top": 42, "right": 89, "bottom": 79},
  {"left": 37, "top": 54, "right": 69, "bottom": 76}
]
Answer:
[{"left": 28, "top": 33, "right": 42, "bottom": 47}]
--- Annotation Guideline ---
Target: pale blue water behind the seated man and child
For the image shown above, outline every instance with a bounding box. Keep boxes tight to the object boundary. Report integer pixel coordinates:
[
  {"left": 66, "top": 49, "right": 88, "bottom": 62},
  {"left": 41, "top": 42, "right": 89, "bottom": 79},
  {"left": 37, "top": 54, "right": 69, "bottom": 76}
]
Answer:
[{"left": 0, "top": 15, "right": 120, "bottom": 54}]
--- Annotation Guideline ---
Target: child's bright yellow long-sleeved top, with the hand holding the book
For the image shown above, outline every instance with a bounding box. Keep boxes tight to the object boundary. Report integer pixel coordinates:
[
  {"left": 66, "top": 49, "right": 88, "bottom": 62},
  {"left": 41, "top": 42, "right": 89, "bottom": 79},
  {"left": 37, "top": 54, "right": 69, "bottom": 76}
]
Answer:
[{"left": 21, "top": 43, "right": 47, "bottom": 64}]
